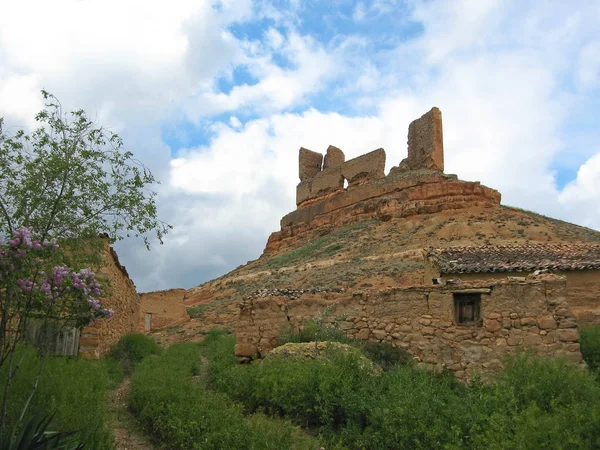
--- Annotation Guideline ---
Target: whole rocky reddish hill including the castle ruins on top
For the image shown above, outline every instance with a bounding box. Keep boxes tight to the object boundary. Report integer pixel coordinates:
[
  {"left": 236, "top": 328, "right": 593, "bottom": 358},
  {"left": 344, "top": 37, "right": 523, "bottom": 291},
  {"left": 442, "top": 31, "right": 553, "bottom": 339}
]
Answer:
[{"left": 150, "top": 108, "right": 600, "bottom": 341}]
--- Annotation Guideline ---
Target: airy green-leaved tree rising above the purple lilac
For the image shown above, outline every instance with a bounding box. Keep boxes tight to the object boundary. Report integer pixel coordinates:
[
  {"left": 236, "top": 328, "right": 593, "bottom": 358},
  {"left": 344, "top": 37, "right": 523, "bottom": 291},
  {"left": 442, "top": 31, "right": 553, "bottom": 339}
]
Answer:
[{"left": 0, "top": 91, "right": 171, "bottom": 255}]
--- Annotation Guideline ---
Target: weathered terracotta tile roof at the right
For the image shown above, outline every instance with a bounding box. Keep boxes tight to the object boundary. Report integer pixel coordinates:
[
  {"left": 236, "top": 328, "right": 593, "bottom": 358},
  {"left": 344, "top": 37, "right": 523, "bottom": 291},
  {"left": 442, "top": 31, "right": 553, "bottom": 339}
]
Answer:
[{"left": 427, "top": 244, "right": 600, "bottom": 273}]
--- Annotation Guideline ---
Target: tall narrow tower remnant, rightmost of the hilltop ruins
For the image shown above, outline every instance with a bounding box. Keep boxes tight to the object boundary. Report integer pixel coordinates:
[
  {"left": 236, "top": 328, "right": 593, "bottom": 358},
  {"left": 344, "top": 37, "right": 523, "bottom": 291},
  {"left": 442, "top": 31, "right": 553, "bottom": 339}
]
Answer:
[{"left": 400, "top": 107, "right": 444, "bottom": 172}]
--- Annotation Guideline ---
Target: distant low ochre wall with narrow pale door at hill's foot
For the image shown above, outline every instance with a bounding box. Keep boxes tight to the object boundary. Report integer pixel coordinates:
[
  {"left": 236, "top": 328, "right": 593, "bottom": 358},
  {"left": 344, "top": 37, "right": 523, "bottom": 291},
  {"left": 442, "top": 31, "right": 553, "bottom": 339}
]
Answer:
[{"left": 139, "top": 289, "right": 190, "bottom": 333}]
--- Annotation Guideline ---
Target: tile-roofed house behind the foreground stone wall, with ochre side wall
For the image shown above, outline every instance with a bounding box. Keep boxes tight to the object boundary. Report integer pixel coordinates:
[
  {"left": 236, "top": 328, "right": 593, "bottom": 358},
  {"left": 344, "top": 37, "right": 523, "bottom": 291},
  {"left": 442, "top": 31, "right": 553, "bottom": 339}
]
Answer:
[{"left": 424, "top": 243, "right": 600, "bottom": 324}]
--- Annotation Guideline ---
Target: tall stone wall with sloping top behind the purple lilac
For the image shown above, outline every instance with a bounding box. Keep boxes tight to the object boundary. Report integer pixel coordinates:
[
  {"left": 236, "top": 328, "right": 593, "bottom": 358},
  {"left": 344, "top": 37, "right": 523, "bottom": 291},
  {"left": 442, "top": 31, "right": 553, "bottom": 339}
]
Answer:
[{"left": 79, "top": 239, "right": 140, "bottom": 358}]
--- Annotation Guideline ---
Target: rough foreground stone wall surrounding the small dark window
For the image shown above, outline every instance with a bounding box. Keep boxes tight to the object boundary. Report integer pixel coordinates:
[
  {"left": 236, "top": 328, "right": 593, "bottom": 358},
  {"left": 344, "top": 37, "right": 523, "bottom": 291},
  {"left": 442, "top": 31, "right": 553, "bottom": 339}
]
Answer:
[{"left": 236, "top": 277, "right": 583, "bottom": 378}]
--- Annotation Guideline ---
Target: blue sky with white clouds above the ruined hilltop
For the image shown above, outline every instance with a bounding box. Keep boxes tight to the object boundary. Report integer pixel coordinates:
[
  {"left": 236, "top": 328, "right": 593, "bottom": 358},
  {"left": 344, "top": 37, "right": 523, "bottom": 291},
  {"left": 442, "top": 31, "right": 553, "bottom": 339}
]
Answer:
[{"left": 0, "top": 0, "right": 600, "bottom": 292}]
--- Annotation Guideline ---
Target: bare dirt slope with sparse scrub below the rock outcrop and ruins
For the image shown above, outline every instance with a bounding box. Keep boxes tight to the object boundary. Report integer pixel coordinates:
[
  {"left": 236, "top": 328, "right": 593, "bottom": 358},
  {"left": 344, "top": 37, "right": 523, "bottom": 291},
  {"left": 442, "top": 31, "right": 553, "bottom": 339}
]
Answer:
[{"left": 150, "top": 206, "right": 600, "bottom": 343}]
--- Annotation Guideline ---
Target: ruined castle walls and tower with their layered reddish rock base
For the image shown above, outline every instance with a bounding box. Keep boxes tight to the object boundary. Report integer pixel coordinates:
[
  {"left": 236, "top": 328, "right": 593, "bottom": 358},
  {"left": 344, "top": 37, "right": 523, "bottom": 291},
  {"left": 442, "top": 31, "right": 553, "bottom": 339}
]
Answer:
[{"left": 265, "top": 108, "right": 501, "bottom": 254}]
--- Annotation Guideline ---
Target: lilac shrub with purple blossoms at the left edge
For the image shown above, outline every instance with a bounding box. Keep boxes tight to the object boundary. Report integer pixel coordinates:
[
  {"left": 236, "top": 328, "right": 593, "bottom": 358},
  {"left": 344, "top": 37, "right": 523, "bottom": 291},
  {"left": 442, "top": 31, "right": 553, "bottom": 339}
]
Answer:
[{"left": 0, "top": 227, "right": 113, "bottom": 435}]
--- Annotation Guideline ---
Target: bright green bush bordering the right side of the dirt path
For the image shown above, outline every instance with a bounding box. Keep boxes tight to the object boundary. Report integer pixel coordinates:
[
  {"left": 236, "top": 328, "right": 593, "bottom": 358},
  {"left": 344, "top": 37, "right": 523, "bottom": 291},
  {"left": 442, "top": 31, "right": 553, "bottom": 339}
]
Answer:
[{"left": 130, "top": 337, "right": 320, "bottom": 450}]
